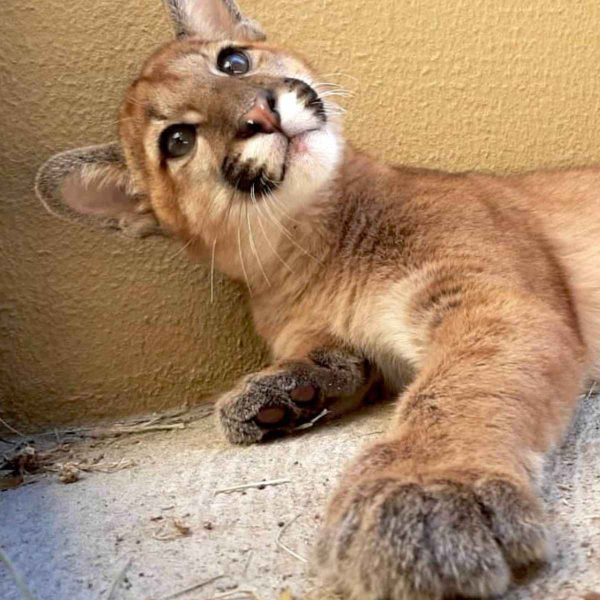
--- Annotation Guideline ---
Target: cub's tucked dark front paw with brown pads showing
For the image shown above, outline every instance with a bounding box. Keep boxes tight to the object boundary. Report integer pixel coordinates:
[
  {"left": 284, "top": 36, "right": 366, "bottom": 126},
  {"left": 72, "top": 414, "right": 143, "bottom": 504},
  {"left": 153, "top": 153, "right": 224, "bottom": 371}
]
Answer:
[{"left": 217, "top": 346, "right": 376, "bottom": 444}]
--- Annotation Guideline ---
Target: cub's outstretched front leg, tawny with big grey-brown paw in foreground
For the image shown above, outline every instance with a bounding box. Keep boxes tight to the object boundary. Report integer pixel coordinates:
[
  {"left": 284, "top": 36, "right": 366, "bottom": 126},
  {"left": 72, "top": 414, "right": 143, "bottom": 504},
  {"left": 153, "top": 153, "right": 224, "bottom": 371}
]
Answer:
[{"left": 316, "top": 286, "right": 585, "bottom": 600}]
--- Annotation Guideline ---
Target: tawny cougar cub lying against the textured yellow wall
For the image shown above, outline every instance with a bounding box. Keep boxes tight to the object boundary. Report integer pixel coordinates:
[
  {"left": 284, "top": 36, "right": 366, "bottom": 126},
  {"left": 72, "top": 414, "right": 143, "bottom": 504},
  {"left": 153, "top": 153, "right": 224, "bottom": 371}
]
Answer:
[{"left": 36, "top": 0, "right": 600, "bottom": 600}]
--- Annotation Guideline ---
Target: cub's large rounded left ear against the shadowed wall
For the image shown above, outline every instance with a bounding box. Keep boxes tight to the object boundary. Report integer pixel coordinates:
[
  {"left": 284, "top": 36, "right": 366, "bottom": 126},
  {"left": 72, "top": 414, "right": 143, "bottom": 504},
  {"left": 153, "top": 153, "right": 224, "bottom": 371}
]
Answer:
[{"left": 35, "top": 143, "right": 165, "bottom": 237}]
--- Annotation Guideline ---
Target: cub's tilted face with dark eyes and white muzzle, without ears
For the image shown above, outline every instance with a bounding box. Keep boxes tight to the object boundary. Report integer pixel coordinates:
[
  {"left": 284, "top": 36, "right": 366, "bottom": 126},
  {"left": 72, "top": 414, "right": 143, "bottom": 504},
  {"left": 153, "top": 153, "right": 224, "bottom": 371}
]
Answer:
[{"left": 120, "top": 38, "right": 342, "bottom": 238}]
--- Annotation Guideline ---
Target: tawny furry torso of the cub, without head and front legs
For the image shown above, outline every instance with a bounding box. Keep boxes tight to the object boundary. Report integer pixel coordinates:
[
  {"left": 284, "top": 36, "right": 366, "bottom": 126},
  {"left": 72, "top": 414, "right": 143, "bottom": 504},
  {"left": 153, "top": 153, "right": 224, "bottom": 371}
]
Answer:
[{"left": 231, "top": 149, "right": 600, "bottom": 391}]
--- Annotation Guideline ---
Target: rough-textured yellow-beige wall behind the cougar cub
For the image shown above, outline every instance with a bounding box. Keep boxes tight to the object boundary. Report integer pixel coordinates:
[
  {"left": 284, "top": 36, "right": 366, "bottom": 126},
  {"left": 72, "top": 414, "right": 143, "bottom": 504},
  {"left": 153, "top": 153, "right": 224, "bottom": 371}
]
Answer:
[{"left": 0, "top": 0, "right": 600, "bottom": 428}]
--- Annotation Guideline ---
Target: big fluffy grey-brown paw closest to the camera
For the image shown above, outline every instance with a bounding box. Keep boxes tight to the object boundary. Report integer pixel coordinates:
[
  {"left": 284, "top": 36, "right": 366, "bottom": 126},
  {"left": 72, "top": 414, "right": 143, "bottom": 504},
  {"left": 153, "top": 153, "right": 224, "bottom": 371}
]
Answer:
[{"left": 316, "top": 464, "right": 549, "bottom": 600}]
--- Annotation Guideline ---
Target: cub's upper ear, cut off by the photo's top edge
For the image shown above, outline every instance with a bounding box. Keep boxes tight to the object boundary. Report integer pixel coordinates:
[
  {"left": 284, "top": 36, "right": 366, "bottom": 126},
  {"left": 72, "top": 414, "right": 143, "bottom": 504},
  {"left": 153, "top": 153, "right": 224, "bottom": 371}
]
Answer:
[{"left": 165, "top": 0, "right": 266, "bottom": 42}]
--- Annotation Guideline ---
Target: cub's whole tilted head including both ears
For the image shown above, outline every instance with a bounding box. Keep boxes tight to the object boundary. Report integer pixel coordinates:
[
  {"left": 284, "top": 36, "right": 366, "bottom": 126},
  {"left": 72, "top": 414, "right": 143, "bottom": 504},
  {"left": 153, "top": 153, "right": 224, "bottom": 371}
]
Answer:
[{"left": 36, "top": 0, "right": 343, "bottom": 244}]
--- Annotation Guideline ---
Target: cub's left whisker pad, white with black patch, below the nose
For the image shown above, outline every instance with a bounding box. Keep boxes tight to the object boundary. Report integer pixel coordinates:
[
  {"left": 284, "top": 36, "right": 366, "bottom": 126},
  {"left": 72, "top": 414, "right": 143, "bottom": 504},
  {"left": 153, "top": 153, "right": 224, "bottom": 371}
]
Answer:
[{"left": 221, "top": 127, "right": 321, "bottom": 197}]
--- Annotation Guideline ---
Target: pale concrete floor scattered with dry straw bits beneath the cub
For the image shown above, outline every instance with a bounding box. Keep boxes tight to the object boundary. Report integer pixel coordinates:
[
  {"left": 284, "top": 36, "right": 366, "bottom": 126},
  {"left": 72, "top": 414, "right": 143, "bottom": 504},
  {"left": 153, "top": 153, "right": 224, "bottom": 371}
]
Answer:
[{"left": 0, "top": 397, "right": 600, "bottom": 600}]
